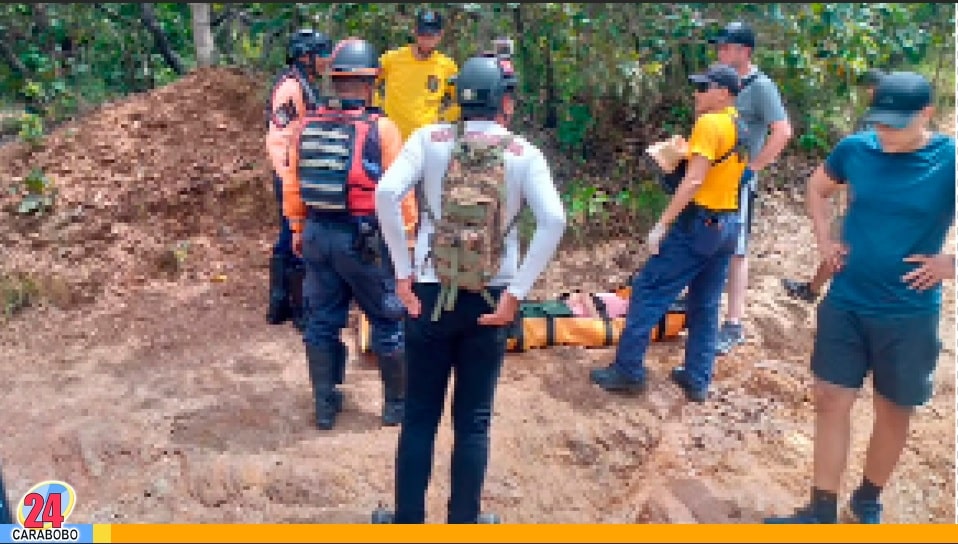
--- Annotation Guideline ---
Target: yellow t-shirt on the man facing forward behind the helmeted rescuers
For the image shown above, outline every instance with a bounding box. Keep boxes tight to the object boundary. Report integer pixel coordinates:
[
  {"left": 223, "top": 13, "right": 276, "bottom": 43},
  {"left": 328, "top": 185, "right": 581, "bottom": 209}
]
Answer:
[{"left": 373, "top": 45, "right": 459, "bottom": 141}]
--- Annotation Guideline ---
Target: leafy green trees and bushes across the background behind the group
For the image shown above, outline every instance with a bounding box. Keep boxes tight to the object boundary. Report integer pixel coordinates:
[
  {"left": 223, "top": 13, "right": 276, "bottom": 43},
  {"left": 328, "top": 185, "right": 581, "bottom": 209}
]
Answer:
[{"left": 0, "top": 3, "right": 955, "bottom": 239}]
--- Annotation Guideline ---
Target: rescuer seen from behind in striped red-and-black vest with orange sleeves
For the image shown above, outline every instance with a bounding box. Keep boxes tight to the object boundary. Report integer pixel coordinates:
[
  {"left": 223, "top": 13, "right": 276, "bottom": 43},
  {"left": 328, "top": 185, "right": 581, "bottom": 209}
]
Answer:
[{"left": 278, "top": 38, "right": 405, "bottom": 430}]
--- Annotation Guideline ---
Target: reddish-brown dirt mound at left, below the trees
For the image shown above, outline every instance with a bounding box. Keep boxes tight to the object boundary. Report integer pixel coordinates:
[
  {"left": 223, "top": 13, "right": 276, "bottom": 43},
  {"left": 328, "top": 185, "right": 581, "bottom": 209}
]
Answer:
[{"left": 0, "top": 68, "right": 275, "bottom": 299}]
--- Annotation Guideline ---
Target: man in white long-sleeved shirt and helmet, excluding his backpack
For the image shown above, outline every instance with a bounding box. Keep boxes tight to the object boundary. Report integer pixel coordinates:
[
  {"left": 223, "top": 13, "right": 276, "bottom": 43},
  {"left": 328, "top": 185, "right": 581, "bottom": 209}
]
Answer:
[{"left": 373, "top": 54, "right": 566, "bottom": 523}]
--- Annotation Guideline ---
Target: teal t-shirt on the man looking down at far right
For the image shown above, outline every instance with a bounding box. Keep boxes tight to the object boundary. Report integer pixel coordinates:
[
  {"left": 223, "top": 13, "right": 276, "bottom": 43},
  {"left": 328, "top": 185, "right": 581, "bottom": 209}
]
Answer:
[{"left": 825, "top": 130, "right": 955, "bottom": 317}]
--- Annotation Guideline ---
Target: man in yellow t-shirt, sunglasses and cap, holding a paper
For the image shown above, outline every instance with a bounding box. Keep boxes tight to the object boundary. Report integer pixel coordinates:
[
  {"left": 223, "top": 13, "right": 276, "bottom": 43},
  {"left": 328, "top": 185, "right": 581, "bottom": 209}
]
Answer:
[{"left": 591, "top": 64, "right": 748, "bottom": 402}]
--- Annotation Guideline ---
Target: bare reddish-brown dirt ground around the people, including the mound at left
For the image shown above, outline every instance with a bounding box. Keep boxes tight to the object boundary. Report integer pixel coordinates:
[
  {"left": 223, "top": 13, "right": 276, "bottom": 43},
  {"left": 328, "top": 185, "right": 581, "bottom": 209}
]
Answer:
[{"left": 0, "top": 66, "right": 956, "bottom": 523}]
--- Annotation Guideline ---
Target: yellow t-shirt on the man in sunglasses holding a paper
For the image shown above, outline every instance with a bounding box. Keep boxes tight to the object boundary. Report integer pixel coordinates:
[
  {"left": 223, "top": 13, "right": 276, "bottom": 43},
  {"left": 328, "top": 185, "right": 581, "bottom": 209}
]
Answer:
[{"left": 688, "top": 107, "right": 745, "bottom": 210}]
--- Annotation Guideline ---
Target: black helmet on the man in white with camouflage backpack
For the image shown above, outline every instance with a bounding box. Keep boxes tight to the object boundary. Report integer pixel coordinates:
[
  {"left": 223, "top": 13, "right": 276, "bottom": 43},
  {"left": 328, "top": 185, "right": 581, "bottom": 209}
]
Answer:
[{"left": 453, "top": 53, "right": 518, "bottom": 115}]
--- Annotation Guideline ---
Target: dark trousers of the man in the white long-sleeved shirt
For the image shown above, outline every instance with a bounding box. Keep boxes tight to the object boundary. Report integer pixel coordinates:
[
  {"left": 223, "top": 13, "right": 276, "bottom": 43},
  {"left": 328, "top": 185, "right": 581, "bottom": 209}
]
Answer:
[{"left": 395, "top": 284, "right": 506, "bottom": 523}]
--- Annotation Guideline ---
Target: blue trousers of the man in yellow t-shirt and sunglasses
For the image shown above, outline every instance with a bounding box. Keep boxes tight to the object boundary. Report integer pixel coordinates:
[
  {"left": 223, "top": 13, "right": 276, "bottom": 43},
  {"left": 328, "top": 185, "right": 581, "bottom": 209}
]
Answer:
[{"left": 615, "top": 205, "right": 740, "bottom": 389}]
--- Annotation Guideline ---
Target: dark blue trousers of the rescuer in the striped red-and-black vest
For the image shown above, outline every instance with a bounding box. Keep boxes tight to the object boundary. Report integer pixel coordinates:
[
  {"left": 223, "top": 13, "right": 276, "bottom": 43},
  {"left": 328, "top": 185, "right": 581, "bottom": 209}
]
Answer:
[{"left": 303, "top": 219, "right": 405, "bottom": 355}]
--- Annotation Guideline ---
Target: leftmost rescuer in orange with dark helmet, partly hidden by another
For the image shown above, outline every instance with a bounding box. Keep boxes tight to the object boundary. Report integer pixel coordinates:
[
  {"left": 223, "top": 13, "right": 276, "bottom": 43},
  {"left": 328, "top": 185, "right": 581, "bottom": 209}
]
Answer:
[{"left": 266, "top": 29, "right": 333, "bottom": 329}]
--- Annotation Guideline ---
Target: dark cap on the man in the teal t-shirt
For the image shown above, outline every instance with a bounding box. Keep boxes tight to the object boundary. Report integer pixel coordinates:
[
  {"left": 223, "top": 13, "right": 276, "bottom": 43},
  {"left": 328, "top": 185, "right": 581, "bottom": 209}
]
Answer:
[{"left": 865, "top": 72, "right": 932, "bottom": 129}]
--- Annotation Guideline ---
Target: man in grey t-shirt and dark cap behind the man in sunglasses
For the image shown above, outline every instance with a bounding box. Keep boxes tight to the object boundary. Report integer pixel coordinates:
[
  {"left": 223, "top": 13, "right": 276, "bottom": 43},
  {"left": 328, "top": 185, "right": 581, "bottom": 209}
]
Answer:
[{"left": 709, "top": 21, "right": 792, "bottom": 355}]
